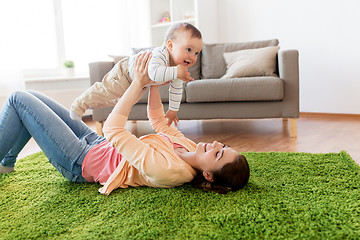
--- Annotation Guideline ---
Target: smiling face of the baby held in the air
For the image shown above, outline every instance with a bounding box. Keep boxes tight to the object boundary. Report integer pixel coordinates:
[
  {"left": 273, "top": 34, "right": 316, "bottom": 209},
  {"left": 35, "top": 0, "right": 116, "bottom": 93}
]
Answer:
[{"left": 167, "top": 30, "right": 203, "bottom": 67}]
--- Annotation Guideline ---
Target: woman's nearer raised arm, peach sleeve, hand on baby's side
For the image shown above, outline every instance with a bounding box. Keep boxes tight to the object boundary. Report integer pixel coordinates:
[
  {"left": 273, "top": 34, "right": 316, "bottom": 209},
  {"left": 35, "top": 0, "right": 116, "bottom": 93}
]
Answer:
[{"left": 103, "top": 53, "right": 172, "bottom": 182}]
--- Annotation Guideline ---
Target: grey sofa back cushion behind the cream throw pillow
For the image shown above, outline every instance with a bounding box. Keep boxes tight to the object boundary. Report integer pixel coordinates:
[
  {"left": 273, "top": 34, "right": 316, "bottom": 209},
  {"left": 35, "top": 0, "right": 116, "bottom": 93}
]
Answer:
[{"left": 201, "top": 39, "right": 279, "bottom": 79}]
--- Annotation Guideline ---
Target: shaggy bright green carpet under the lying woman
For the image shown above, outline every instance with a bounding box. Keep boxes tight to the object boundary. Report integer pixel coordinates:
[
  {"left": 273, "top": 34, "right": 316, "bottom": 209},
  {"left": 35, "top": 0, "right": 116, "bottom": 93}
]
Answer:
[{"left": 0, "top": 152, "right": 360, "bottom": 239}]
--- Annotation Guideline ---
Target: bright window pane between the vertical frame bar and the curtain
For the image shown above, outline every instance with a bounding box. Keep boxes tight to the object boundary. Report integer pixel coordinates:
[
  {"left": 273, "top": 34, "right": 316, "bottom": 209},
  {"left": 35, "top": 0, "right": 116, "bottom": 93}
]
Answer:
[{"left": 62, "top": 0, "right": 131, "bottom": 71}]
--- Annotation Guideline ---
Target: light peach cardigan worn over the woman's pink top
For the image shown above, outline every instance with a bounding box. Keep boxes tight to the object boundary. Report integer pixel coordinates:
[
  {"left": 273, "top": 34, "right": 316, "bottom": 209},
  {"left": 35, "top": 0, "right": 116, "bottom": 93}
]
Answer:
[{"left": 99, "top": 107, "right": 196, "bottom": 195}]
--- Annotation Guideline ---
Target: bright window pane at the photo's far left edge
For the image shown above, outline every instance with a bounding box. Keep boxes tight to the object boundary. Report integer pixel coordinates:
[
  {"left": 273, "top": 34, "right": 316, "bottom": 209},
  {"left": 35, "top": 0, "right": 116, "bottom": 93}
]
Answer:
[{"left": 0, "top": 0, "right": 58, "bottom": 74}]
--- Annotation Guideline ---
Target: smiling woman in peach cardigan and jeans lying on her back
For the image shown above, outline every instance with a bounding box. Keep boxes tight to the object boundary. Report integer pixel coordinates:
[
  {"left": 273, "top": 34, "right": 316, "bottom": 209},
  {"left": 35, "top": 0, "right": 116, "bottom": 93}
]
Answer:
[{"left": 0, "top": 53, "right": 249, "bottom": 195}]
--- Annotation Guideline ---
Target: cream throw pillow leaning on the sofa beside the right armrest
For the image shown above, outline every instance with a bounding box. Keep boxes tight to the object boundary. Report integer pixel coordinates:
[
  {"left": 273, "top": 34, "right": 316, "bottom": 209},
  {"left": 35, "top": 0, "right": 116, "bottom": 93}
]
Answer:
[{"left": 221, "top": 46, "right": 280, "bottom": 79}]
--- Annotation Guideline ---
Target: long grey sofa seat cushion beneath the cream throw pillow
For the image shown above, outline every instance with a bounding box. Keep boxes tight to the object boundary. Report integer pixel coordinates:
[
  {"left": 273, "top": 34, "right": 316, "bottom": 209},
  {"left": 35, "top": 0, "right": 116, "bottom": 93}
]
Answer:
[{"left": 185, "top": 76, "right": 284, "bottom": 103}]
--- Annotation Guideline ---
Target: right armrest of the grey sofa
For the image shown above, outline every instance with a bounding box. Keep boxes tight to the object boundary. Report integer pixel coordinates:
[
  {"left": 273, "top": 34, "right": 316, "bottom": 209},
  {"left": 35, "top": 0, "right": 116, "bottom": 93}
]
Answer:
[{"left": 278, "top": 50, "right": 299, "bottom": 118}]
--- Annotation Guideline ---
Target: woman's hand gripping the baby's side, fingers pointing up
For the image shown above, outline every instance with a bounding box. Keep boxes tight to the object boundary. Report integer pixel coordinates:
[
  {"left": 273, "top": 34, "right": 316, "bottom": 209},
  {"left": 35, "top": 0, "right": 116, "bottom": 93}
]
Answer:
[{"left": 133, "top": 51, "right": 154, "bottom": 88}]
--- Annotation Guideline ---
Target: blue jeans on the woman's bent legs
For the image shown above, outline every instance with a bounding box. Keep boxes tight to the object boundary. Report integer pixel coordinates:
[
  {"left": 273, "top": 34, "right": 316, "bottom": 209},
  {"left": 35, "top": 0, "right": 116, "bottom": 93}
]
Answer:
[{"left": 0, "top": 91, "right": 105, "bottom": 182}]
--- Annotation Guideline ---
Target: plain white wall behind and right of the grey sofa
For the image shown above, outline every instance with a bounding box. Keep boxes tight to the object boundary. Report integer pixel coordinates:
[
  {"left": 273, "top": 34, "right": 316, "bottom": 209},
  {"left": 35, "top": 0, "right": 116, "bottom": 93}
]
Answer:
[{"left": 218, "top": 0, "right": 360, "bottom": 114}]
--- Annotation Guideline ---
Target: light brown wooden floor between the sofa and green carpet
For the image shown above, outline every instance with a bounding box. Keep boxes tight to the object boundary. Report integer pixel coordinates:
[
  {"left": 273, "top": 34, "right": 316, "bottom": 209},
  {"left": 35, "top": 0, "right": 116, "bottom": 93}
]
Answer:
[{"left": 19, "top": 113, "right": 360, "bottom": 165}]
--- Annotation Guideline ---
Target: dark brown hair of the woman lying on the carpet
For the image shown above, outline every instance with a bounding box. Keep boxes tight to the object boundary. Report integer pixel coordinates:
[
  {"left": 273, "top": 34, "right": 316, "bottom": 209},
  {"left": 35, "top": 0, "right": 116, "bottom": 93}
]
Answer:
[{"left": 192, "top": 154, "right": 250, "bottom": 193}]
